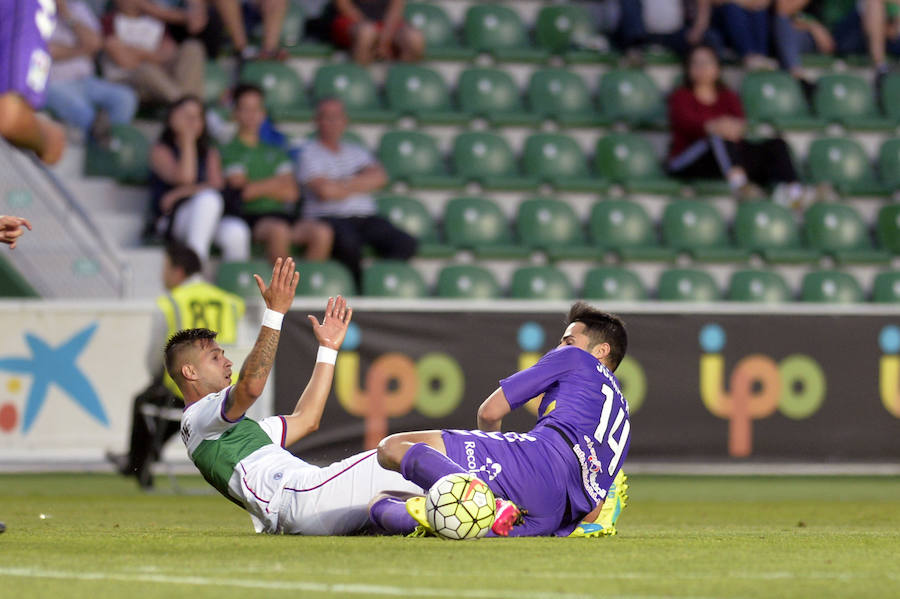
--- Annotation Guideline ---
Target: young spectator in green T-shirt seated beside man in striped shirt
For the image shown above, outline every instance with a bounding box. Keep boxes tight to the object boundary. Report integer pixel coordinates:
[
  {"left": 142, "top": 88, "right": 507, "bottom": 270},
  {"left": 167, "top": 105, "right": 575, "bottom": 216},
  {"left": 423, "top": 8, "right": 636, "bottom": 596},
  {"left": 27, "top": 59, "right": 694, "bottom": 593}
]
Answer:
[{"left": 222, "top": 84, "right": 333, "bottom": 264}]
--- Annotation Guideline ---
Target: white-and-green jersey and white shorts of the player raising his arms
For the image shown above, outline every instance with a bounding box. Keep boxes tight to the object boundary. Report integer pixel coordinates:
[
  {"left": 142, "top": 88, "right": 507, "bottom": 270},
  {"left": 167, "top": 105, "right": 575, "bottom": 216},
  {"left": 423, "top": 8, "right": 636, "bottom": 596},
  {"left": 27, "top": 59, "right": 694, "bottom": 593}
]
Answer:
[{"left": 181, "top": 387, "right": 422, "bottom": 535}]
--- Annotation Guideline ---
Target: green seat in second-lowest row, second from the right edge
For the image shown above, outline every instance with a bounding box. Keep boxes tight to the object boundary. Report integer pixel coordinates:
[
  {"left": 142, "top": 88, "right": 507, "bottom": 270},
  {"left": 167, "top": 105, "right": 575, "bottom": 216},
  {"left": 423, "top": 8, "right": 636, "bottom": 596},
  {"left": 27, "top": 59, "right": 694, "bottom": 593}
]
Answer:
[{"left": 804, "top": 202, "right": 889, "bottom": 262}]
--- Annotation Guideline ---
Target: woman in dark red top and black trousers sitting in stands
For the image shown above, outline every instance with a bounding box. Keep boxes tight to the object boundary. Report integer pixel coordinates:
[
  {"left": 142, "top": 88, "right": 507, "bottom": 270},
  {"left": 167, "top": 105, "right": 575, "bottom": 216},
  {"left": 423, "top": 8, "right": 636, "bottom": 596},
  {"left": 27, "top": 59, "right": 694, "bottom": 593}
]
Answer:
[{"left": 667, "top": 46, "right": 804, "bottom": 205}]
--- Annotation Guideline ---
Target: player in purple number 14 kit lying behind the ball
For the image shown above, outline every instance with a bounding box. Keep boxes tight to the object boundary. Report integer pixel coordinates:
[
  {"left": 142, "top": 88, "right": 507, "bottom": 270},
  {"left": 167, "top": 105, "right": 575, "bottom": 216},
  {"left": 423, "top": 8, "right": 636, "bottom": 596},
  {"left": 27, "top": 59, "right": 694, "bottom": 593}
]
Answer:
[{"left": 370, "top": 302, "right": 631, "bottom": 536}]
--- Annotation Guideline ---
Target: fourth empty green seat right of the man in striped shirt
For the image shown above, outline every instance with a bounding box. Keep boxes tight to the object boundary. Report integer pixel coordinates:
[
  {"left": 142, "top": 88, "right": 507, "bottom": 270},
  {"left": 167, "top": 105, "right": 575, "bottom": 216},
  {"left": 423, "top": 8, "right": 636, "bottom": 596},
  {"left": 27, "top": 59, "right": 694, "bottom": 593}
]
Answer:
[{"left": 588, "top": 200, "right": 675, "bottom": 261}]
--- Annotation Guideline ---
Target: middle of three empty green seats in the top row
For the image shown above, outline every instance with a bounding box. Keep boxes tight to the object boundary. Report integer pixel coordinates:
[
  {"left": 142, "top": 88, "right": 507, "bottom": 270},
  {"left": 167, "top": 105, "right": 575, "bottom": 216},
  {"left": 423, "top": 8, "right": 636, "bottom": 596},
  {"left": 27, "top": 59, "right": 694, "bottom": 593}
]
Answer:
[{"left": 463, "top": 3, "right": 547, "bottom": 61}]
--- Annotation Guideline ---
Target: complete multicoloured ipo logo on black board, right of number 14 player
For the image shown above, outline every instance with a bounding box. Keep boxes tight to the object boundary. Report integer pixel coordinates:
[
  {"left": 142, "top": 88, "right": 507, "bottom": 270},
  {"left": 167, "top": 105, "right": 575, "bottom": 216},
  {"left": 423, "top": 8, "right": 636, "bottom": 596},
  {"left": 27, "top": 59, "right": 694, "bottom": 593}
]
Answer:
[{"left": 700, "top": 324, "right": 826, "bottom": 458}]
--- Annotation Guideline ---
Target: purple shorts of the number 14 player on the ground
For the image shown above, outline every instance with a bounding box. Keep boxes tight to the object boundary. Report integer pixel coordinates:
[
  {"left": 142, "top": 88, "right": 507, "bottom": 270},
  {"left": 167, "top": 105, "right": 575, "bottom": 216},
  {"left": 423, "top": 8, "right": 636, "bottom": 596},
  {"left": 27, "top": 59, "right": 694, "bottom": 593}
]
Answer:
[{"left": 441, "top": 430, "right": 580, "bottom": 536}]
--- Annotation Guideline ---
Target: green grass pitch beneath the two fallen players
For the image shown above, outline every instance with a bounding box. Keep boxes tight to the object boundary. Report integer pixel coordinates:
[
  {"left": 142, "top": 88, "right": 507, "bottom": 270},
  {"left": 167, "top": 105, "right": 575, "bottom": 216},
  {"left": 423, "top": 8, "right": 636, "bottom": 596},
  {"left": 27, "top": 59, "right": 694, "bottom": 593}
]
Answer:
[{"left": 0, "top": 474, "right": 900, "bottom": 599}]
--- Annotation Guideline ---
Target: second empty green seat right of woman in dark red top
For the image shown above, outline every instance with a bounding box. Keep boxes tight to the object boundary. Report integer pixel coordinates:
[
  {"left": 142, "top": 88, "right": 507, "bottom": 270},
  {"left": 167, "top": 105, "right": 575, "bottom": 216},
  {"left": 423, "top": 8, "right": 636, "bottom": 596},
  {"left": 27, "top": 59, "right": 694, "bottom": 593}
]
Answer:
[{"left": 813, "top": 74, "right": 892, "bottom": 130}]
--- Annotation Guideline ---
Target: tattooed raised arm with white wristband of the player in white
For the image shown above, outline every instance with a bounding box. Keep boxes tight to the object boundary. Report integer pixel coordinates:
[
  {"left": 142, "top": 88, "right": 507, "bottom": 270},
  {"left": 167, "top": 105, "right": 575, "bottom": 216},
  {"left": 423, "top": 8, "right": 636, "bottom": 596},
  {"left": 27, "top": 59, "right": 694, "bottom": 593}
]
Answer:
[{"left": 225, "top": 258, "right": 300, "bottom": 420}]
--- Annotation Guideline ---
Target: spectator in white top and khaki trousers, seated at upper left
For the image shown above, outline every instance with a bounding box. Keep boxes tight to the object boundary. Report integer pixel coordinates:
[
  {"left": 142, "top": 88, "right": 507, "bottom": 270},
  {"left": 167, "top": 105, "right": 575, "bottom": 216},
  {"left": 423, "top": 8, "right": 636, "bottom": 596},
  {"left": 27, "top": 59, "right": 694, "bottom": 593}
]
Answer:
[{"left": 103, "top": 0, "right": 205, "bottom": 104}]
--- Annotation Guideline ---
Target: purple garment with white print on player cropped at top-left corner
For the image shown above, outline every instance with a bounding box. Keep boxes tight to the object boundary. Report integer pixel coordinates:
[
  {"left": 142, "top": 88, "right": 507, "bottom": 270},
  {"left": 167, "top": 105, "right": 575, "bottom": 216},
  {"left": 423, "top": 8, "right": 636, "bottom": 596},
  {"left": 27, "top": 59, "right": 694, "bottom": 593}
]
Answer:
[{"left": 0, "top": 0, "right": 56, "bottom": 108}]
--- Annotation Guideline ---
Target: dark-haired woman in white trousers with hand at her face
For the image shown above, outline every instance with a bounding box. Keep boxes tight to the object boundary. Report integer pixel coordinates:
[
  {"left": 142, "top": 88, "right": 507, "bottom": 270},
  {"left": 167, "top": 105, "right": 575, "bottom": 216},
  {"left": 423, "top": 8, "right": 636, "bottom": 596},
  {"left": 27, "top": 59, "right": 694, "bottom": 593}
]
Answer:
[{"left": 150, "top": 96, "right": 250, "bottom": 261}]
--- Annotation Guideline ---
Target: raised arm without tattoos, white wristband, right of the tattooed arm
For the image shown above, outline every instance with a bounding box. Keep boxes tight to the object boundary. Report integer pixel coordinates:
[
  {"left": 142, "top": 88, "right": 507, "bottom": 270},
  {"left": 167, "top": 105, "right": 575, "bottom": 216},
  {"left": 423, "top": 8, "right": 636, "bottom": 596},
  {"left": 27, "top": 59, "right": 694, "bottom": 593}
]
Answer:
[{"left": 284, "top": 296, "right": 353, "bottom": 447}]
